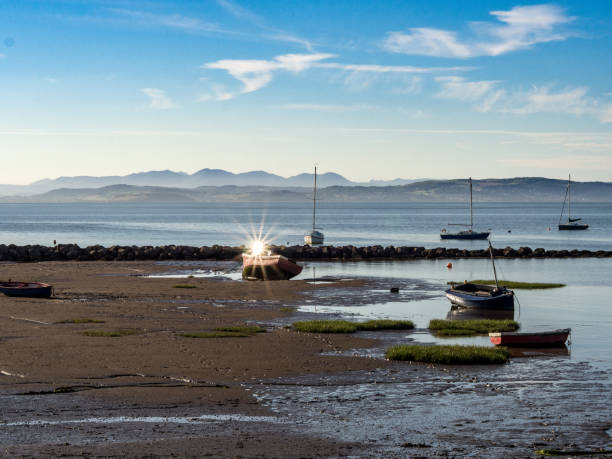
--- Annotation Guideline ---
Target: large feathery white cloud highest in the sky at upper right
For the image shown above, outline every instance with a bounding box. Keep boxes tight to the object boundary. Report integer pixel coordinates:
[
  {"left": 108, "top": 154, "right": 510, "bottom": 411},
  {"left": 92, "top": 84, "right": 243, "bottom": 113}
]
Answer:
[{"left": 383, "top": 5, "right": 575, "bottom": 59}]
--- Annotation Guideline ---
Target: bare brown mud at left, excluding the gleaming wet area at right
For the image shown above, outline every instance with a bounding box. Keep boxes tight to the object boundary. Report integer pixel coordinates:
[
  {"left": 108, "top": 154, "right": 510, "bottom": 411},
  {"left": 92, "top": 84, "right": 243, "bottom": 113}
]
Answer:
[{"left": 0, "top": 262, "right": 385, "bottom": 456}]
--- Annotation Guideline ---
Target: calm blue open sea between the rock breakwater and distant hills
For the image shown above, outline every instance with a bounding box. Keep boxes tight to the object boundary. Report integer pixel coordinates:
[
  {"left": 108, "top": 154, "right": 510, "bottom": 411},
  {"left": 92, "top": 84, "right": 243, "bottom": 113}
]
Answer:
[{"left": 0, "top": 203, "right": 612, "bottom": 250}]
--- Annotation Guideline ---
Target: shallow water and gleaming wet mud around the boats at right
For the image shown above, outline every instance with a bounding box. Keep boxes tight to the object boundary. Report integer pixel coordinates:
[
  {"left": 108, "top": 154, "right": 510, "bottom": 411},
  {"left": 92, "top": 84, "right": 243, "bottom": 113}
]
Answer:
[{"left": 142, "top": 259, "right": 612, "bottom": 456}]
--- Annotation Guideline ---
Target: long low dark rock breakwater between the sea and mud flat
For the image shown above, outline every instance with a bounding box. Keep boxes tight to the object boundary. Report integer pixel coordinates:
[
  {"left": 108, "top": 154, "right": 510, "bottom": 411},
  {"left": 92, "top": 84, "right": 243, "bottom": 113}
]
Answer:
[{"left": 0, "top": 244, "right": 612, "bottom": 262}]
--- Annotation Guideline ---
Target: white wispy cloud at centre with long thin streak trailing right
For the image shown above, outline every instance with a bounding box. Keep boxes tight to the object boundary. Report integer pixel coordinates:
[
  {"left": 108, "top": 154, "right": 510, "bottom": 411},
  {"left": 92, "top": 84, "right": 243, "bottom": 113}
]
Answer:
[{"left": 200, "top": 53, "right": 466, "bottom": 100}]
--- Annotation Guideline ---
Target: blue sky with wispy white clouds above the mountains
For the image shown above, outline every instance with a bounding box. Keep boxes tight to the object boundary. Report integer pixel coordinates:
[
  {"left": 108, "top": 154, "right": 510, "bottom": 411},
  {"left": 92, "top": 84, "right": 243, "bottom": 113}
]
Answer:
[{"left": 0, "top": 0, "right": 612, "bottom": 184}]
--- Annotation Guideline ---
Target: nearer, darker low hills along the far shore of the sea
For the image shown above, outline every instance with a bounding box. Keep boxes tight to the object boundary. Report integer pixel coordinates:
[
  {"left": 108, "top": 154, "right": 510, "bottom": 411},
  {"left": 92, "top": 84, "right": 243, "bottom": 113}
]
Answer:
[{"left": 0, "top": 177, "right": 612, "bottom": 204}]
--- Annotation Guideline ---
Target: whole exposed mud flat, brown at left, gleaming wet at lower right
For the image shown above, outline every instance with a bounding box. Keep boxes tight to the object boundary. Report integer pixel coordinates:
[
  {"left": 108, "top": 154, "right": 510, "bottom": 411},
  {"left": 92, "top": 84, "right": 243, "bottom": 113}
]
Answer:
[{"left": 0, "top": 261, "right": 612, "bottom": 457}]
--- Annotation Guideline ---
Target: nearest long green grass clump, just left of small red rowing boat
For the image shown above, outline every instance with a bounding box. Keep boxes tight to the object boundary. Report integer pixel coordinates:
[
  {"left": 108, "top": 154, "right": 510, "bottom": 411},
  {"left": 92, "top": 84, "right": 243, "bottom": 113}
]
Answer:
[{"left": 385, "top": 344, "right": 510, "bottom": 365}]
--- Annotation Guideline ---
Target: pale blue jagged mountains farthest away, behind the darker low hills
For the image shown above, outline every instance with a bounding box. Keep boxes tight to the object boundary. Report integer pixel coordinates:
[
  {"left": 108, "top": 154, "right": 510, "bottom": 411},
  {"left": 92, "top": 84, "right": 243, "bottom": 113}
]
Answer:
[{"left": 0, "top": 169, "right": 424, "bottom": 196}]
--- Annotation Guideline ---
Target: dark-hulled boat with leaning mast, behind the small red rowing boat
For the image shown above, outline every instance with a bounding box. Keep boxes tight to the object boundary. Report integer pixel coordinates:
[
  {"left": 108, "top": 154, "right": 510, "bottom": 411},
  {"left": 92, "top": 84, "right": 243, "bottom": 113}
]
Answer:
[{"left": 445, "top": 241, "right": 514, "bottom": 309}]
